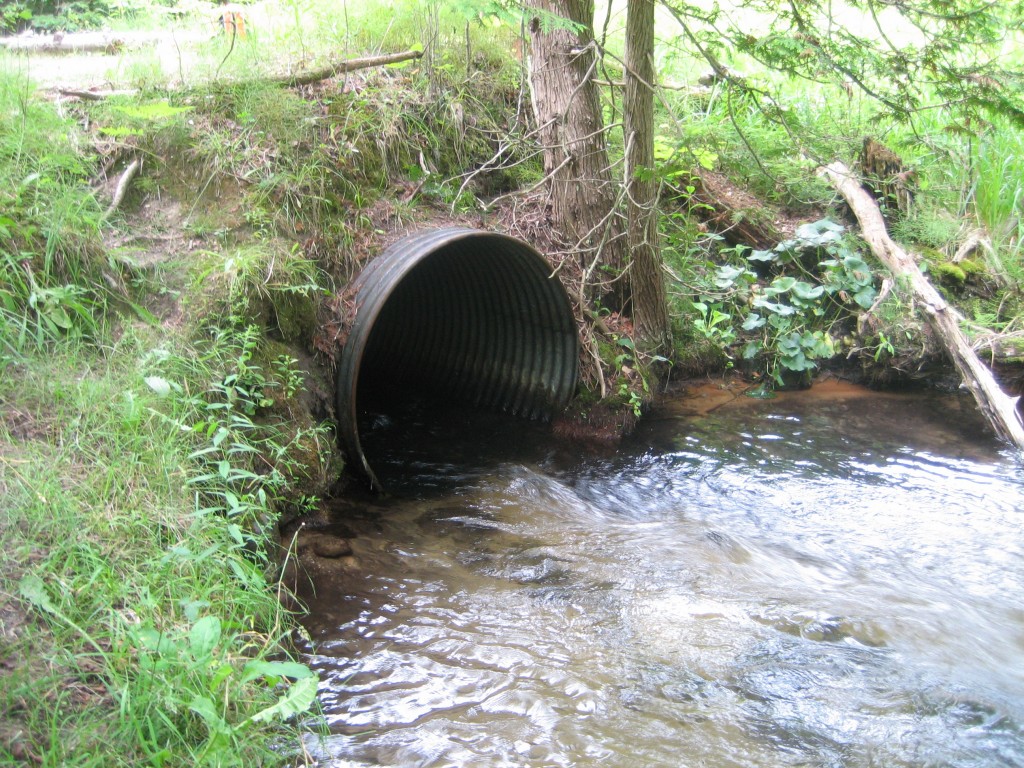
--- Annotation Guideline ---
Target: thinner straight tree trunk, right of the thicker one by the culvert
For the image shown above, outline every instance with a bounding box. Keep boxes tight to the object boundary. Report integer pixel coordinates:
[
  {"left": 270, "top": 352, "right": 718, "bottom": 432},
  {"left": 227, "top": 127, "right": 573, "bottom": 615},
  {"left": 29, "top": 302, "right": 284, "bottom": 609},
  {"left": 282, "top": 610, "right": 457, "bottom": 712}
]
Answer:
[{"left": 623, "top": 0, "right": 672, "bottom": 354}]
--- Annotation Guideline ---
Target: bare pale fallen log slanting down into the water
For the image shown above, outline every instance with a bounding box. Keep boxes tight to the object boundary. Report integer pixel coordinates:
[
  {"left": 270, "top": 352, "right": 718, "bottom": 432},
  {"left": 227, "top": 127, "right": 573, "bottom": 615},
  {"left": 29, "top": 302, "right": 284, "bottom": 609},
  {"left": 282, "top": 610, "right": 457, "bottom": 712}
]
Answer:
[{"left": 818, "top": 163, "right": 1024, "bottom": 451}]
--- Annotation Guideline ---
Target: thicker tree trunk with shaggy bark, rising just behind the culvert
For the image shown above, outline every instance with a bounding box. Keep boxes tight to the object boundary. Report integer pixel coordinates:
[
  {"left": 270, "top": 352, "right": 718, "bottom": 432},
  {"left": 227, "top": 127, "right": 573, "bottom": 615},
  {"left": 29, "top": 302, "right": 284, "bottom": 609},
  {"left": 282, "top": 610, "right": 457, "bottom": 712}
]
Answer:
[{"left": 526, "top": 0, "right": 628, "bottom": 296}]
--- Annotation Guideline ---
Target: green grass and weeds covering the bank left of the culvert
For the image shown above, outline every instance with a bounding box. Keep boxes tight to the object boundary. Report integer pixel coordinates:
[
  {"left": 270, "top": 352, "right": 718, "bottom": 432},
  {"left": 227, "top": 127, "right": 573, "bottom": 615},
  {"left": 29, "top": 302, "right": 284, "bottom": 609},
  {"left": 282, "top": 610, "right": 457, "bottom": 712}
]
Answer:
[{"left": 0, "top": 67, "right": 332, "bottom": 766}]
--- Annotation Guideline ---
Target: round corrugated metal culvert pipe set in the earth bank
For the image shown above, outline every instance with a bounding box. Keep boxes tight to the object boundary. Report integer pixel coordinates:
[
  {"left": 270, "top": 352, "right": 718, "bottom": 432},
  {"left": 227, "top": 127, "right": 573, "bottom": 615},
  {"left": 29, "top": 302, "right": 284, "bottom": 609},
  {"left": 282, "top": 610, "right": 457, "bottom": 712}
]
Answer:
[{"left": 337, "top": 228, "right": 579, "bottom": 488}]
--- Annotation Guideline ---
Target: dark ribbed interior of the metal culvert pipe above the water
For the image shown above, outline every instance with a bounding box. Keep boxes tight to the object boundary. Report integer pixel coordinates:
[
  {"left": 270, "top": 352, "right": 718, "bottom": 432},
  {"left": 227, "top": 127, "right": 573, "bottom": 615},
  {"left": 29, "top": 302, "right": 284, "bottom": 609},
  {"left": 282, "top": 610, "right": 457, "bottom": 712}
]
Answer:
[{"left": 357, "top": 241, "right": 575, "bottom": 419}]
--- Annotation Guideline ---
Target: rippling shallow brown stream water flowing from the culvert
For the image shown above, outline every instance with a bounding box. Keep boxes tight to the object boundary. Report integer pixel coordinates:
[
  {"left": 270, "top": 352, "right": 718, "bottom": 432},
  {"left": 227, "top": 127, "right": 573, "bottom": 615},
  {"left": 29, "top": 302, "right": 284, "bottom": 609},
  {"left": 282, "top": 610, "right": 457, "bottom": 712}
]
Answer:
[{"left": 294, "top": 384, "right": 1024, "bottom": 768}]
